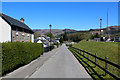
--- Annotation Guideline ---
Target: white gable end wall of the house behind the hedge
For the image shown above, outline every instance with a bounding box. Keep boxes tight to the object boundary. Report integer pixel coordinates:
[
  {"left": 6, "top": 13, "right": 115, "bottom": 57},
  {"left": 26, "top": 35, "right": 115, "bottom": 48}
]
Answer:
[{"left": 0, "top": 17, "right": 11, "bottom": 43}]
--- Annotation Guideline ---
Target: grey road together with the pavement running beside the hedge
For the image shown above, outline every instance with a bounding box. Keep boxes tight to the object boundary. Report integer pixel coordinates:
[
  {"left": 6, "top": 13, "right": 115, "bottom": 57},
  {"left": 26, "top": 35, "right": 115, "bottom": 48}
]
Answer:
[{"left": 5, "top": 45, "right": 91, "bottom": 78}]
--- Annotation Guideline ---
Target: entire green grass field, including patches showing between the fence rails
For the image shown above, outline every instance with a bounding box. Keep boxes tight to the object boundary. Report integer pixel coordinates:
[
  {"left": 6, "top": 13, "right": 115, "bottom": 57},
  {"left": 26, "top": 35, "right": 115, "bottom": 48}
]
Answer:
[{"left": 71, "top": 41, "right": 120, "bottom": 78}]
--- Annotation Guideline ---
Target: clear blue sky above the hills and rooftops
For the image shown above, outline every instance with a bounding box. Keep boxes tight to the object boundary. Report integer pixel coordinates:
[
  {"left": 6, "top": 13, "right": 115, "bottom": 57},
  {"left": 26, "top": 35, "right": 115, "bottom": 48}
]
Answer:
[{"left": 2, "top": 2, "right": 118, "bottom": 30}]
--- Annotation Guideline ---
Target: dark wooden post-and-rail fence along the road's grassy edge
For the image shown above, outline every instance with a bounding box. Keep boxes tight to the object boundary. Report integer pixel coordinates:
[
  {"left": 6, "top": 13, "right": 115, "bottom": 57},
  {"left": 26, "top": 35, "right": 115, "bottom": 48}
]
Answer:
[{"left": 69, "top": 46, "right": 120, "bottom": 80}]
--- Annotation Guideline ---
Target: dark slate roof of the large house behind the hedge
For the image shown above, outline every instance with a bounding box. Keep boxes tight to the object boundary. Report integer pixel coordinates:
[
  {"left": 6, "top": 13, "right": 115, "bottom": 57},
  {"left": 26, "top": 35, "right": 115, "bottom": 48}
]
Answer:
[{"left": 2, "top": 13, "right": 34, "bottom": 33}]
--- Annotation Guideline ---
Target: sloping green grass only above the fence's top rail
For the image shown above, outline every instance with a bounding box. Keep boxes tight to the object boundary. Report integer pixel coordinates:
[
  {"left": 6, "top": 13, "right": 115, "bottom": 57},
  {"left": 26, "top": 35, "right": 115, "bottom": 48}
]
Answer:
[{"left": 73, "top": 41, "right": 118, "bottom": 64}]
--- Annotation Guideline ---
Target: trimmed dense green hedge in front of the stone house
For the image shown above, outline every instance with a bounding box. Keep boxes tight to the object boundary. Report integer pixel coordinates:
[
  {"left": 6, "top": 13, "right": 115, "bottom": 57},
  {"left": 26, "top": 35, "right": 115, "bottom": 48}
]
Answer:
[{"left": 2, "top": 42, "right": 44, "bottom": 75}]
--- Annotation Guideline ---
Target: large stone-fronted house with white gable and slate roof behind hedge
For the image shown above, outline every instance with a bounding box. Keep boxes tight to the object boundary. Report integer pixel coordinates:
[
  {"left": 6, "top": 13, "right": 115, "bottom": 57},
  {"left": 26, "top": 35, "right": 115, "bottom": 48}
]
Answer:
[{"left": 0, "top": 13, "right": 34, "bottom": 42}]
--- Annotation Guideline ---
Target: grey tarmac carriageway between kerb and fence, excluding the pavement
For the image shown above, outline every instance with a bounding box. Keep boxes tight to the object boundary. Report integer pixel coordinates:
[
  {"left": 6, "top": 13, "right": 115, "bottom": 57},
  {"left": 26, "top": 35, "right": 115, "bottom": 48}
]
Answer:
[{"left": 30, "top": 45, "right": 91, "bottom": 78}]
